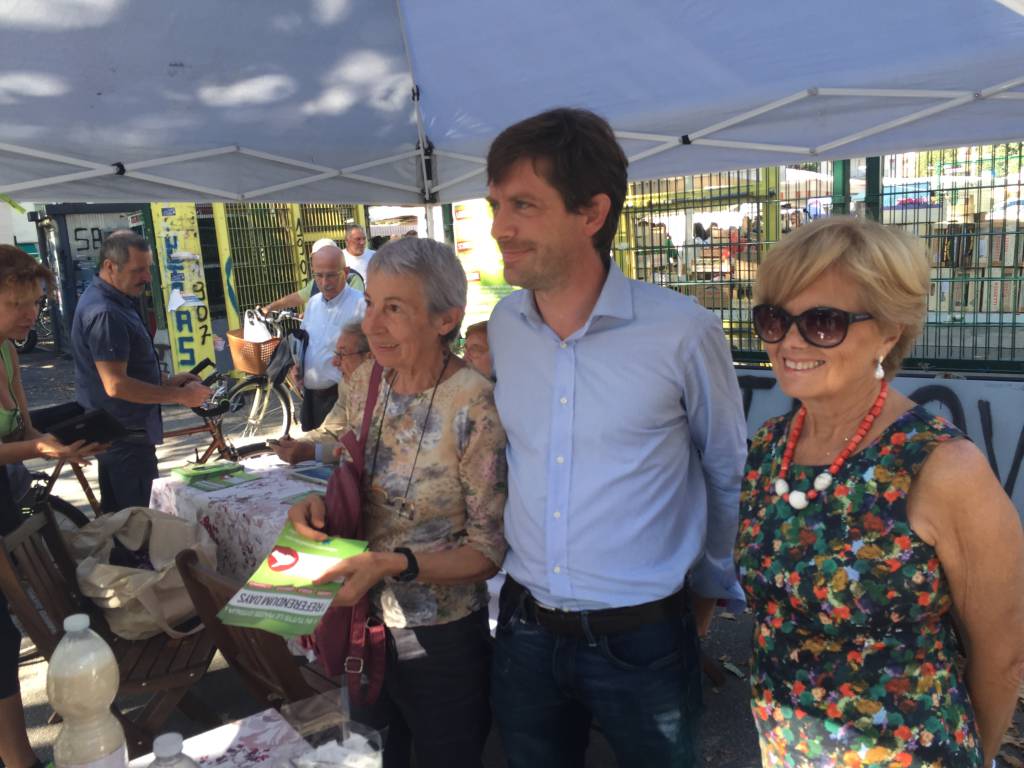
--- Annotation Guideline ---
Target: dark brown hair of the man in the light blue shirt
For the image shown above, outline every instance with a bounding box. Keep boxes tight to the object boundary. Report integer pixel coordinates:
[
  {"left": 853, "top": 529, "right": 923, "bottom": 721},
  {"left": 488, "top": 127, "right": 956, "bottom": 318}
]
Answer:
[{"left": 487, "top": 108, "right": 629, "bottom": 266}]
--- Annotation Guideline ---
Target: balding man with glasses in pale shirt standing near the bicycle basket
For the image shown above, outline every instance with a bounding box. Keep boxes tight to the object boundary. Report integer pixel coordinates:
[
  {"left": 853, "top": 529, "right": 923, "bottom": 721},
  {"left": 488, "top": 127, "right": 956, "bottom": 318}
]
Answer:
[{"left": 300, "top": 245, "right": 366, "bottom": 431}]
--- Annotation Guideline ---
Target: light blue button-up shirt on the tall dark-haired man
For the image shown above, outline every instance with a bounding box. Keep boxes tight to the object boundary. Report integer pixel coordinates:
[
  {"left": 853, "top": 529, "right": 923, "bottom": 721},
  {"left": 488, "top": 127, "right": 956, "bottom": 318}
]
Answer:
[{"left": 487, "top": 264, "right": 746, "bottom": 610}]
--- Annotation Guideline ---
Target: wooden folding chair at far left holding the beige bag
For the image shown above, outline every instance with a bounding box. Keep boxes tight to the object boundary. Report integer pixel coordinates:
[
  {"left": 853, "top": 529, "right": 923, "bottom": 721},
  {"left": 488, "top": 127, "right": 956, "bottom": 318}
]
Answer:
[{"left": 0, "top": 505, "right": 220, "bottom": 757}]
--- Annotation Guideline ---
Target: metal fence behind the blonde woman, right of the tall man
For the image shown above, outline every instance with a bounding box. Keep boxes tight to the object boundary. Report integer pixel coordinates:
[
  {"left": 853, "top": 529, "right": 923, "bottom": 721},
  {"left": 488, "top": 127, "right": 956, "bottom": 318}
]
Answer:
[{"left": 615, "top": 142, "right": 1024, "bottom": 373}]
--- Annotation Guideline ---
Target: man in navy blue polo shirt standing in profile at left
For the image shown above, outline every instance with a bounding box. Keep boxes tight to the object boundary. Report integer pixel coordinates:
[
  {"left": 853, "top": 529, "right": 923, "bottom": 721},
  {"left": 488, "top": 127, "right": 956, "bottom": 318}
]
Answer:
[{"left": 71, "top": 229, "right": 210, "bottom": 512}]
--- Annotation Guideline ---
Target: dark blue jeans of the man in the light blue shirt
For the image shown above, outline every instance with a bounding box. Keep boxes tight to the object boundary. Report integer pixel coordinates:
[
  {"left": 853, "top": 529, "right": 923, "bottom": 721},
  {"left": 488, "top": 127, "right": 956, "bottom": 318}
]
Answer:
[{"left": 492, "top": 590, "right": 700, "bottom": 768}]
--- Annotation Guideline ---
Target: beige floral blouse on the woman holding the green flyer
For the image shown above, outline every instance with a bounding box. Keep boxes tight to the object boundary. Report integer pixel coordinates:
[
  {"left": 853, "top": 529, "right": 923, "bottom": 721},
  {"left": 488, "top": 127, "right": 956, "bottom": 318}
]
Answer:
[{"left": 343, "top": 360, "right": 508, "bottom": 628}]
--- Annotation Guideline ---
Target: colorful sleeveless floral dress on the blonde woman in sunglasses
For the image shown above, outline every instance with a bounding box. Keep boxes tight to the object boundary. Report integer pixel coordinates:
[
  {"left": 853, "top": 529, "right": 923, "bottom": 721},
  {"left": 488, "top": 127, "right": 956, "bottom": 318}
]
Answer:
[{"left": 736, "top": 406, "right": 982, "bottom": 768}]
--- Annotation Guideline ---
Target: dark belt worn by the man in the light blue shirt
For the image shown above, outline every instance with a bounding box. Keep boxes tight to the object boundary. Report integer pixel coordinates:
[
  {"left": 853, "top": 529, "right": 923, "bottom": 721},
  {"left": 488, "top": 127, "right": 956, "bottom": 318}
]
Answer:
[{"left": 502, "top": 575, "right": 687, "bottom": 637}]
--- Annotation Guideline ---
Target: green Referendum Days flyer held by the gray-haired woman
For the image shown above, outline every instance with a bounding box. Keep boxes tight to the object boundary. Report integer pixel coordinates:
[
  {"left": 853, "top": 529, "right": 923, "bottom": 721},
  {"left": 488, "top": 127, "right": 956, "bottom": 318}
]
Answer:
[{"left": 217, "top": 522, "right": 368, "bottom": 637}]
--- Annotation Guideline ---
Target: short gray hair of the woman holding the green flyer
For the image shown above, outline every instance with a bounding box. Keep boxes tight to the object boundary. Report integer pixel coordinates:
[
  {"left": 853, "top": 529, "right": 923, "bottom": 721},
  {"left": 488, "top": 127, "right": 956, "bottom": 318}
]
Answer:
[{"left": 367, "top": 238, "right": 467, "bottom": 344}]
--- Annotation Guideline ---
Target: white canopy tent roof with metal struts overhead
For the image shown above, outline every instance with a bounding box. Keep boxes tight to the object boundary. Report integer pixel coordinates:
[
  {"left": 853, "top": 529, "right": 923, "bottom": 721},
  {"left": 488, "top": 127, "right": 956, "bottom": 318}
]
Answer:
[{"left": 0, "top": 0, "right": 1024, "bottom": 203}]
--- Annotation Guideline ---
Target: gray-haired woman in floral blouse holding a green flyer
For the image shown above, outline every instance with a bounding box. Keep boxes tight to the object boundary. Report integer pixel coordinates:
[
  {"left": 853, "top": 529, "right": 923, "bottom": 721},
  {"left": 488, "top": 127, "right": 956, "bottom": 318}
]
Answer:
[{"left": 289, "top": 238, "right": 507, "bottom": 768}]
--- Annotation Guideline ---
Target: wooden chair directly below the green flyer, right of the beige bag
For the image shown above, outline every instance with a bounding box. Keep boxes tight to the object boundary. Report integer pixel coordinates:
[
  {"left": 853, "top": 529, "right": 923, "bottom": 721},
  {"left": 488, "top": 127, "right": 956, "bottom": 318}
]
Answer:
[{"left": 176, "top": 550, "right": 338, "bottom": 708}]
